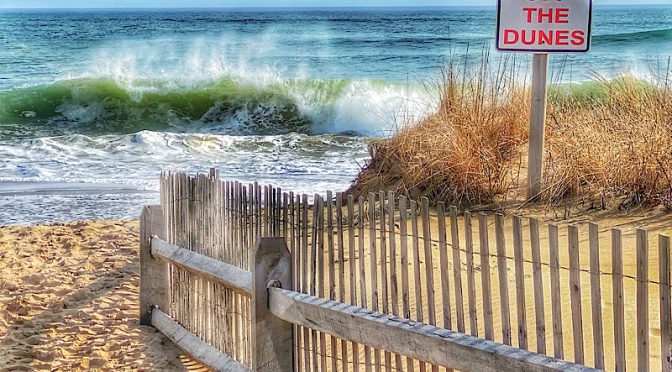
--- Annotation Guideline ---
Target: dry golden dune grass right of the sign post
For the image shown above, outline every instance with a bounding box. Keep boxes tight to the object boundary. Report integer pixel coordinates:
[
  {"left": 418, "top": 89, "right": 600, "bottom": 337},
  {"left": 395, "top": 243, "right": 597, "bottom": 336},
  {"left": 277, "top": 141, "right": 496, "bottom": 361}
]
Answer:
[{"left": 544, "top": 66, "right": 672, "bottom": 208}]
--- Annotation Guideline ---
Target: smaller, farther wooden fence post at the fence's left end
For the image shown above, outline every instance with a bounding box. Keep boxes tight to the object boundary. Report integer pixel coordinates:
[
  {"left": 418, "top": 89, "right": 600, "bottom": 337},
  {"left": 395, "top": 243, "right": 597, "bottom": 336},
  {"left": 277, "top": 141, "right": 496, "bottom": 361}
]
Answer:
[{"left": 140, "top": 205, "right": 170, "bottom": 326}]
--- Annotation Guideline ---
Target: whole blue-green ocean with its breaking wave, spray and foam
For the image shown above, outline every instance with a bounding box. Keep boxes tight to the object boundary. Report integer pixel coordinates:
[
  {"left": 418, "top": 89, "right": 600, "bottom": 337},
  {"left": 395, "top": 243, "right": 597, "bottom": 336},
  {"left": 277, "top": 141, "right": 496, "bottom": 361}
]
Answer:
[{"left": 0, "top": 4, "right": 672, "bottom": 225}]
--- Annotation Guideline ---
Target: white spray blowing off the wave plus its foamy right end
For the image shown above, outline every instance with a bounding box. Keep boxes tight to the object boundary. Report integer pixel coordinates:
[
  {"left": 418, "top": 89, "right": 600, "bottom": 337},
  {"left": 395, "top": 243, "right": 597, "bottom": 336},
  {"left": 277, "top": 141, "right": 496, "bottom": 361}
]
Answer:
[{"left": 67, "top": 31, "right": 436, "bottom": 136}]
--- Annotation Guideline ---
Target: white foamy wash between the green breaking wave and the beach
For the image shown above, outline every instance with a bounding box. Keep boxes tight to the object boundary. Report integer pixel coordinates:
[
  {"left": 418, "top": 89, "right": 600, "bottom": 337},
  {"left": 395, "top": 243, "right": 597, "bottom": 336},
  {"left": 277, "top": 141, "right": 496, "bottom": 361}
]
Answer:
[{"left": 0, "top": 131, "right": 367, "bottom": 192}]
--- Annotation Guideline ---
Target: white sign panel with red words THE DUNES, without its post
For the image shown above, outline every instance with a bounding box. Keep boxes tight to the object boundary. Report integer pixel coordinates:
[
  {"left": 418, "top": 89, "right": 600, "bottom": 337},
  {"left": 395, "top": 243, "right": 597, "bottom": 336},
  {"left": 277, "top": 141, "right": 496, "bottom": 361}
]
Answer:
[{"left": 497, "top": 0, "right": 593, "bottom": 53}]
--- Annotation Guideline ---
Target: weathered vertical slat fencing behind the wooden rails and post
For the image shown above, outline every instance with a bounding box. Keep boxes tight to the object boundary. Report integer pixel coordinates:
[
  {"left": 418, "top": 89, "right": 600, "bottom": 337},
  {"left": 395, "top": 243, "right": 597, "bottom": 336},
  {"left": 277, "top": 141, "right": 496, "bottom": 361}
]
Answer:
[{"left": 141, "top": 172, "right": 672, "bottom": 371}]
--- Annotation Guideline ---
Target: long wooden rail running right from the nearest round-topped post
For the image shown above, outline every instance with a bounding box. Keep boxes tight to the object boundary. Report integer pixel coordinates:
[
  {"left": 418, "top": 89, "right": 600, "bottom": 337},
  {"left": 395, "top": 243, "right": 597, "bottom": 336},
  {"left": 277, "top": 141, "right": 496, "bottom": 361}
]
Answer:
[{"left": 269, "top": 288, "right": 597, "bottom": 372}]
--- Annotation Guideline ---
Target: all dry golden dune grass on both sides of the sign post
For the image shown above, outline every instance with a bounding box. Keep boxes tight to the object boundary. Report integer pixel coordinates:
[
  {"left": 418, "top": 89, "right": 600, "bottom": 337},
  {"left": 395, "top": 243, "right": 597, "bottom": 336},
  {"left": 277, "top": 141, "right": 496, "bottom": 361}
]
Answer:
[{"left": 350, "top": 56, "right": 672, "bottom": 212}]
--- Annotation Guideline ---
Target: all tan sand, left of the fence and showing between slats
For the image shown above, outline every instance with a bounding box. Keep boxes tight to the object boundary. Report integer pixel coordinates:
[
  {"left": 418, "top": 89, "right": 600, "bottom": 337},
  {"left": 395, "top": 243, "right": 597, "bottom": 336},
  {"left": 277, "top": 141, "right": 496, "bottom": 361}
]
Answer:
[{"left": 0, "top": 208, "right": 672, "bottom": 371}]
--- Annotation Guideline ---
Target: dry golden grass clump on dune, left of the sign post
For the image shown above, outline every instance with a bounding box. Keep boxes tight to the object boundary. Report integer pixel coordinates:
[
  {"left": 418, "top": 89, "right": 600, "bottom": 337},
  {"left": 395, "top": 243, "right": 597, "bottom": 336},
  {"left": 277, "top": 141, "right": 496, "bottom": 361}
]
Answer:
[{"left": 350, "top": 51, "right": 529, "bottom": 204}]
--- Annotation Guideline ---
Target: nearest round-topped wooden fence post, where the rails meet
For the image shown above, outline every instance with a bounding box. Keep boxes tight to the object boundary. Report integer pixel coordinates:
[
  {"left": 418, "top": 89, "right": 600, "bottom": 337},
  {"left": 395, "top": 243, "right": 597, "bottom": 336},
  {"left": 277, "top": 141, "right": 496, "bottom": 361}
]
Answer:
[{"left": 252, "top": 238, "right": 294, "bottom": 372}]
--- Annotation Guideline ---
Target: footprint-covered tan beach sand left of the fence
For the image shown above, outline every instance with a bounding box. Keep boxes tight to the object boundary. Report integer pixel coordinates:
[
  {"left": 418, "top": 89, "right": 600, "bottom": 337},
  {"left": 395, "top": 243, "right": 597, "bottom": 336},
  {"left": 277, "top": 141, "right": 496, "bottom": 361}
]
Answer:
[{"left": 0, "top": 221, "right": 202, "bottom": 371}]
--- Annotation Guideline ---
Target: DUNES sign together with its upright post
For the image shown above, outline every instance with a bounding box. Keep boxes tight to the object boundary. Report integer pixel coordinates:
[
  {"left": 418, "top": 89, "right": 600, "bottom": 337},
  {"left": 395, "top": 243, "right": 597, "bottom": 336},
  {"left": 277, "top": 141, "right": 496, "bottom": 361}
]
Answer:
[{"left": 497, "top": 0, "right": 593, "bottom": 199}]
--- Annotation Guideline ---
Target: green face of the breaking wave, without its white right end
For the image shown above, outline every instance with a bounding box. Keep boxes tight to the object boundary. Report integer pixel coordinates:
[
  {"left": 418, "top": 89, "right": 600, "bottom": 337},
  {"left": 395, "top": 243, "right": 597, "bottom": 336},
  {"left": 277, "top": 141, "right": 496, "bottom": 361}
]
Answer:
[{"left": 0, "top": 79, "right": 310, "bottom": 134}]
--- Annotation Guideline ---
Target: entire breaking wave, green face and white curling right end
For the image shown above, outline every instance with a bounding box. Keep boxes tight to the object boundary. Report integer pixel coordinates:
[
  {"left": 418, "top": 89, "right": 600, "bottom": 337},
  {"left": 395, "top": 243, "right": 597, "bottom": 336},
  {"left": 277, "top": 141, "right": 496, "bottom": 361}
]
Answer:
[{"left": 0, "top": 77, "right": 427, "bottom": 136}]
